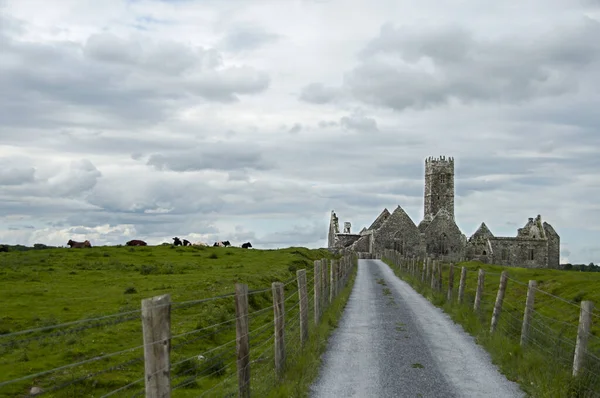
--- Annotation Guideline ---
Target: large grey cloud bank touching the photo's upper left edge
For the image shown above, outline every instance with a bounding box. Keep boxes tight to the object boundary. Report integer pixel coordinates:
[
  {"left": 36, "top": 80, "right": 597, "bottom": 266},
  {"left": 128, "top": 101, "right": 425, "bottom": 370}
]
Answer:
[{"left": 0, "top": 22, "right": 270, "bottom": 135}]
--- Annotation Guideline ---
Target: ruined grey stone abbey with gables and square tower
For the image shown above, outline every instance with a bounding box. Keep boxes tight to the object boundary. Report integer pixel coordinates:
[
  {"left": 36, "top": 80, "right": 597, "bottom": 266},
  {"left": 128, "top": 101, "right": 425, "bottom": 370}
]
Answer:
[{"left": 328, "top": 157, "right": 560, "bottom": 268}]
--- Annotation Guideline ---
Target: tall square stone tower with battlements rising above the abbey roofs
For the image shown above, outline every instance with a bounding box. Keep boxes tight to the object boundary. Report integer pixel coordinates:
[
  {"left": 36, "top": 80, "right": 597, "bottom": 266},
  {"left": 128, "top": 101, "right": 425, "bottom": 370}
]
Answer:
[{"left": 424, "top": 156, "right": 454, "bottom": 220}]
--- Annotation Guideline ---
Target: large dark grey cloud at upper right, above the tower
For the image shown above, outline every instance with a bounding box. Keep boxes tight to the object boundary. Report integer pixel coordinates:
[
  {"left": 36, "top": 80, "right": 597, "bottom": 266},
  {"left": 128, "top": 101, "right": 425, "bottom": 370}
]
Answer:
[{"left": 344, "top": 18, "right": 600, "bottom": 110}]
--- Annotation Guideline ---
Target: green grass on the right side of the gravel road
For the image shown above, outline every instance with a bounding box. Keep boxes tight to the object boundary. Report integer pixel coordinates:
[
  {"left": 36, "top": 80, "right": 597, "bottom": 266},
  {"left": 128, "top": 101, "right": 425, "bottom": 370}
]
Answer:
[{"left": 386, "top": 259, "right": 600, "bottom": 398}]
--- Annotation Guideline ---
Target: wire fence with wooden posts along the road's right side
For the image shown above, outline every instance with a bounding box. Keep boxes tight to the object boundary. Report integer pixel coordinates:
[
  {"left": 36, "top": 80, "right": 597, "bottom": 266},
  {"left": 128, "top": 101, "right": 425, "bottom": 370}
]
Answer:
[{"left": 379, "top": 249, "right": 600, "bottom": 397}]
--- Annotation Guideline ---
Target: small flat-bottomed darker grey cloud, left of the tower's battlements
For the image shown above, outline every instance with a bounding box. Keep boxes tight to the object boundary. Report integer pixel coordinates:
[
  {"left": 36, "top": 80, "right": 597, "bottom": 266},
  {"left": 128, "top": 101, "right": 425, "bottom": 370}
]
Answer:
[{"left": 147, "top": 143, "right": 273, "bottom": 172}]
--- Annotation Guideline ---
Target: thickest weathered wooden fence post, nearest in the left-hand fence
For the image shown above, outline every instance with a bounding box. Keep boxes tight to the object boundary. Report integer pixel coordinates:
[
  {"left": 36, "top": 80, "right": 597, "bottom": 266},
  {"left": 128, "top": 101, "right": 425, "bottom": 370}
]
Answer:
[{"left": 142, "top": 294, "right": 171, "bottom": 398}]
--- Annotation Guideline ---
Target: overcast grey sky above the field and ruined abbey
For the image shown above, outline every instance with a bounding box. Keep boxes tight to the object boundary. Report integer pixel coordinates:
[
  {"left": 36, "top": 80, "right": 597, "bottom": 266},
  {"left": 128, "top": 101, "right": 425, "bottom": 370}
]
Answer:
[{"left": 0, "top": 0, "right": 600, "bottom": 263}]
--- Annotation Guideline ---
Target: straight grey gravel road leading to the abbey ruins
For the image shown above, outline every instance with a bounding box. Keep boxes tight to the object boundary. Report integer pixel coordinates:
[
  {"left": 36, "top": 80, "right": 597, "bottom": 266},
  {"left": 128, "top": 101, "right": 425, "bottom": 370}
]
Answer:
[{"left": 311, "top": 260, "right": 525, "bottom": 398}]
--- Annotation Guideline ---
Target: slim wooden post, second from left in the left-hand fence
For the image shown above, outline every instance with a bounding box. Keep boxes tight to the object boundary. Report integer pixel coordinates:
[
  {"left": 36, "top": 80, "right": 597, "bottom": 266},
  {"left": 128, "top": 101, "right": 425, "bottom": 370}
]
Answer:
[{"left": 235, "top": 283, "right": 250, "bottom": 398}]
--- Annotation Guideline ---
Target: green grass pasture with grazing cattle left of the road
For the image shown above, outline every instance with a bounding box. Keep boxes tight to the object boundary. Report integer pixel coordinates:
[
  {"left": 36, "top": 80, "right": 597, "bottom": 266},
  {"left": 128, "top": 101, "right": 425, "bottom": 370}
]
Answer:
[{"left": 0, "top": 246, "right": 343, "bottom": 397}]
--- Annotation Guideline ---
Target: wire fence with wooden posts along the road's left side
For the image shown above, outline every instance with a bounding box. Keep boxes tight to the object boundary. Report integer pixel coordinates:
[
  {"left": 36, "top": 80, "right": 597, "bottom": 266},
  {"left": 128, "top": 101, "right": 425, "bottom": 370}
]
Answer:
[{"left": 0, "top": 253, "right": 357, "bottom": 397}]
